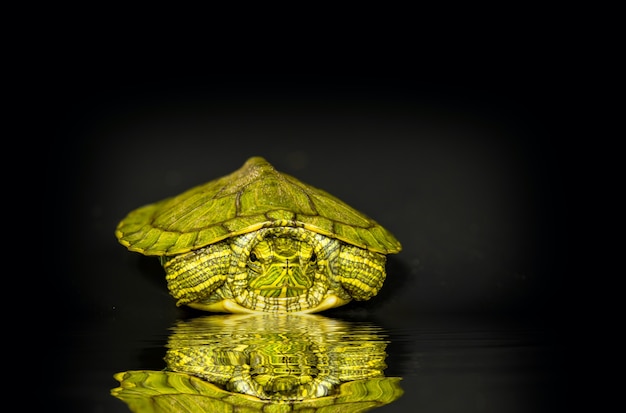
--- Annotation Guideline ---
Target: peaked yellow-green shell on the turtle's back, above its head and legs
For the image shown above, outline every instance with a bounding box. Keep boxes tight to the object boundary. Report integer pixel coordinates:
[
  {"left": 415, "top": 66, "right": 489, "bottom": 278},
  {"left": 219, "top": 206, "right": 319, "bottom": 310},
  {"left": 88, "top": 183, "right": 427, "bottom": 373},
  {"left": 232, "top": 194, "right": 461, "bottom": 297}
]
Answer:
[{"left": 116, "top": 157, "right": 401, "bottom": 256}]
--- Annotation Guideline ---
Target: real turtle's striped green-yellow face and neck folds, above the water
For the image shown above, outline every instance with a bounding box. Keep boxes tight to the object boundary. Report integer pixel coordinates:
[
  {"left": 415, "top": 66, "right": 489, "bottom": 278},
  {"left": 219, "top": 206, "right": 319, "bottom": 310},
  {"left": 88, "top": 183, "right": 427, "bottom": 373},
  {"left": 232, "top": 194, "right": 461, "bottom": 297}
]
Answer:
[{"left": 227, "top": 227, "right": 350, "bottom": 312}]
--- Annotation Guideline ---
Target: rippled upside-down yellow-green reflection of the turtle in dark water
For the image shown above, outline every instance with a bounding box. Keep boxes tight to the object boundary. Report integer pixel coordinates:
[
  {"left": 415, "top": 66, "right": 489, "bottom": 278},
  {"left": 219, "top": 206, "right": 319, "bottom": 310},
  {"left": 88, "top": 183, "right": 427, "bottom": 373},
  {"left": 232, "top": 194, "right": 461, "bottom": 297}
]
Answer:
[{"left": 112, "top": 314, "right": 402, "bottom": 412}]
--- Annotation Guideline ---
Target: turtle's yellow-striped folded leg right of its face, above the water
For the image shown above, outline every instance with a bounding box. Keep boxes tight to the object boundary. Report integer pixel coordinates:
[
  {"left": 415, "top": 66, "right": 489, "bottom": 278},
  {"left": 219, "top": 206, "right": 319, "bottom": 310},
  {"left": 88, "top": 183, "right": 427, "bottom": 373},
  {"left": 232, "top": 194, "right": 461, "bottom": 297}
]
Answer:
[{"left": 336, "top": 244, "right": 386, "bottom": 301}]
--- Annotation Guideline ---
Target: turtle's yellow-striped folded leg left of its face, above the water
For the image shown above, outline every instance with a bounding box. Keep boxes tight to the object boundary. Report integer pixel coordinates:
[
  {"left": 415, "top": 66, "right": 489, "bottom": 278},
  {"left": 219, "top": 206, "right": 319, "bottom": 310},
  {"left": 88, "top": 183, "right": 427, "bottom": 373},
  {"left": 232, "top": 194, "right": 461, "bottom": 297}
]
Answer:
[{"left": 161, "top": 238, "right": 232, "bottom": 306}]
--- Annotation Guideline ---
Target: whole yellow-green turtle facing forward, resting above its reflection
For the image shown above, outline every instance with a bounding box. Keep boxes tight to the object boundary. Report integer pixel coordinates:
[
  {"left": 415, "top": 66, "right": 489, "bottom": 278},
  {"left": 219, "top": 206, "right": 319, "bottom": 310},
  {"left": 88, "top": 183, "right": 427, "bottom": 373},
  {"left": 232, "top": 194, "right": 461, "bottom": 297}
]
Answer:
[{"left": 115, "top": 156, "right": 402, "bottom": 313}]
